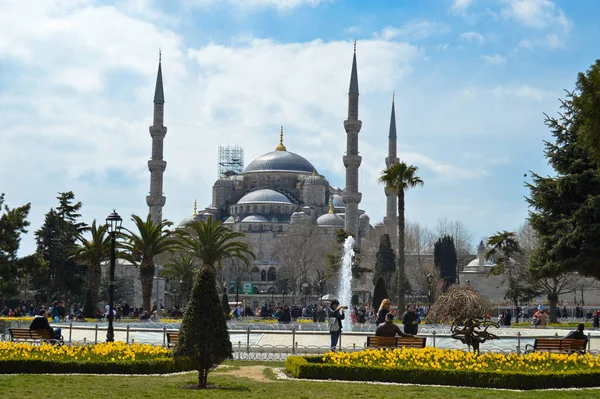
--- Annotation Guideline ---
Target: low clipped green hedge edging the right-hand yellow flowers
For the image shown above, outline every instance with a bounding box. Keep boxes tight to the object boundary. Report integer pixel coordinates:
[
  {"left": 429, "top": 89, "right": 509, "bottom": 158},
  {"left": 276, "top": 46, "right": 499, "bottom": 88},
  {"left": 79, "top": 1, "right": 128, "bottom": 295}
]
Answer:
[{"left": 285, "top": 356, "right": 600, "bottom": 389}]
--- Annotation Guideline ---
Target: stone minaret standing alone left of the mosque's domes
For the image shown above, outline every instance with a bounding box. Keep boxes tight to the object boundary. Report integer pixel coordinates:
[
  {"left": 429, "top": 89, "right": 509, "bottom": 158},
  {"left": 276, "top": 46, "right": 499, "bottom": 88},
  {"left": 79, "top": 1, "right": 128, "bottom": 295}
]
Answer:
[{"left": 146, "top": 52, "right": 167, "bottom": 223}]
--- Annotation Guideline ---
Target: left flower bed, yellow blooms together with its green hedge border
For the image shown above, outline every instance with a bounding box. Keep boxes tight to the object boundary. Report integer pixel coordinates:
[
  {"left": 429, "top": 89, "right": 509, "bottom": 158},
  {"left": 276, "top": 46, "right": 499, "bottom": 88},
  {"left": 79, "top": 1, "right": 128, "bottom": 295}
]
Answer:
[{"left": 0, "top": 342, "right": 192, "bottom": 374}]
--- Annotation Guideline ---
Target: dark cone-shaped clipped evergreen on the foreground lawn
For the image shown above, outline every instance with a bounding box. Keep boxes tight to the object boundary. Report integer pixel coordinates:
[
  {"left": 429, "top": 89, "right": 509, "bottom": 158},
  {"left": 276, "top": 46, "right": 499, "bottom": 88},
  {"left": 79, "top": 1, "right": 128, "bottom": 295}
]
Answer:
[{"left": 175, "top": 266, "right": 233, "bottom": 388}]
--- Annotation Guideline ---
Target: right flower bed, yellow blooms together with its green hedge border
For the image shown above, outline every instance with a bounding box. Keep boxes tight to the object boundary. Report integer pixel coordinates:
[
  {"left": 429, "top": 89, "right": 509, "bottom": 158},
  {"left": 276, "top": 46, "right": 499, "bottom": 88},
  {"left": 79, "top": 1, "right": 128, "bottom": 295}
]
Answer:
[{"left": 286, "top": 348, "right": 600, "bottom": 389}]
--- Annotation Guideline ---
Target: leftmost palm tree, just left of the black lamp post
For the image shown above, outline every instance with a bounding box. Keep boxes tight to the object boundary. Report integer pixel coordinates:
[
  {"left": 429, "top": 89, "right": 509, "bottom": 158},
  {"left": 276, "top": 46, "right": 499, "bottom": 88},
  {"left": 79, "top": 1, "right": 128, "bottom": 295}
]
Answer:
[{"left": 74, "top": 219, "right": 111, "bottom": 317}]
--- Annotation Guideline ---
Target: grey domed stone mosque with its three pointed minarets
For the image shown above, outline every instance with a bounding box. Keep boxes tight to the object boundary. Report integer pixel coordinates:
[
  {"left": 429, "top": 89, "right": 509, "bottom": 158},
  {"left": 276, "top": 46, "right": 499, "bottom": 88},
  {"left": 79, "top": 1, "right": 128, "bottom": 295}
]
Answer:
[{"left": 140, "top": 45, "right": 398, "bottom": 310}]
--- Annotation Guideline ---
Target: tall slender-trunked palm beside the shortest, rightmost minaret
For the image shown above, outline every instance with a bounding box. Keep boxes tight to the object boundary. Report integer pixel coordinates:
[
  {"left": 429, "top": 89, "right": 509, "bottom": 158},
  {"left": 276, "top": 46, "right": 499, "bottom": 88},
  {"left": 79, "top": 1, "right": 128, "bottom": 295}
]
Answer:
[{"left": 379, "top": 162, "right": 423, "bottom": 318}]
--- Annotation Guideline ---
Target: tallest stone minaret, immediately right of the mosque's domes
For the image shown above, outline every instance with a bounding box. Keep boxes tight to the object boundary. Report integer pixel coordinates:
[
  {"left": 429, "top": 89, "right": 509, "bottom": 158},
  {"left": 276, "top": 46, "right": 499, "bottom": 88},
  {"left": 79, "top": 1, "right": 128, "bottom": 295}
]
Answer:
[{"left": 342, "top": 41, "right": 362, "bottom": 240}]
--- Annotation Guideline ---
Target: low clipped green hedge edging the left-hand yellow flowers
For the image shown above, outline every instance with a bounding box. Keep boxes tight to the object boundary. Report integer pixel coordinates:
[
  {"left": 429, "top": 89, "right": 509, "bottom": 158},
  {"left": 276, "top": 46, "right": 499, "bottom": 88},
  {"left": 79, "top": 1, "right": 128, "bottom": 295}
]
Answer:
[{"left": 0, "top": 358, "right": 194, "bottom": 374}]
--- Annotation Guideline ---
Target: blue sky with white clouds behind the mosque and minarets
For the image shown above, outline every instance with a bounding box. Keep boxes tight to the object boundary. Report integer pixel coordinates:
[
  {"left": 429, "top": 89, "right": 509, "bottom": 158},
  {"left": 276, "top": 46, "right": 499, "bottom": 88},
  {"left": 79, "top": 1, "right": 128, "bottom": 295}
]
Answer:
[{"left": 0, "top": 0, "right": 600, "bottom": 255}]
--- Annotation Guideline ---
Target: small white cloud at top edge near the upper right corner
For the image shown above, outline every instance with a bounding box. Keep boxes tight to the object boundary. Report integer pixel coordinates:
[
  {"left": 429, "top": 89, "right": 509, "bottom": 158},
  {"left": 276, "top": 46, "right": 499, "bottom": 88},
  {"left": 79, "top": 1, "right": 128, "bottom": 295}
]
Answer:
[{"left": 501, "top": 0, "right": 571, "bottom": 31}]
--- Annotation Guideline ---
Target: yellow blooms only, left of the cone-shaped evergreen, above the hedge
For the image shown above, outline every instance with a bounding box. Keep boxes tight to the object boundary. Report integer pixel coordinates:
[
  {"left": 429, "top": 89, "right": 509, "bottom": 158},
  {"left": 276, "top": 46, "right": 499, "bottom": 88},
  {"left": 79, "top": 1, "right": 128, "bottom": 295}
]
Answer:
[{"left": 0, "top": 342, "right": 173, "bottom": 362}]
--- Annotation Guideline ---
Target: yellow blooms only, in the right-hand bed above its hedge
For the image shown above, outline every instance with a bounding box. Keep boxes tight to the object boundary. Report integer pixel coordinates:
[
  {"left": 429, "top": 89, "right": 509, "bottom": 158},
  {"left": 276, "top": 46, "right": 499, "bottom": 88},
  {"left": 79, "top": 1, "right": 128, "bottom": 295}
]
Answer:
[{"left": 323, "top": 347, "right": 600, "bottom": 373}]
